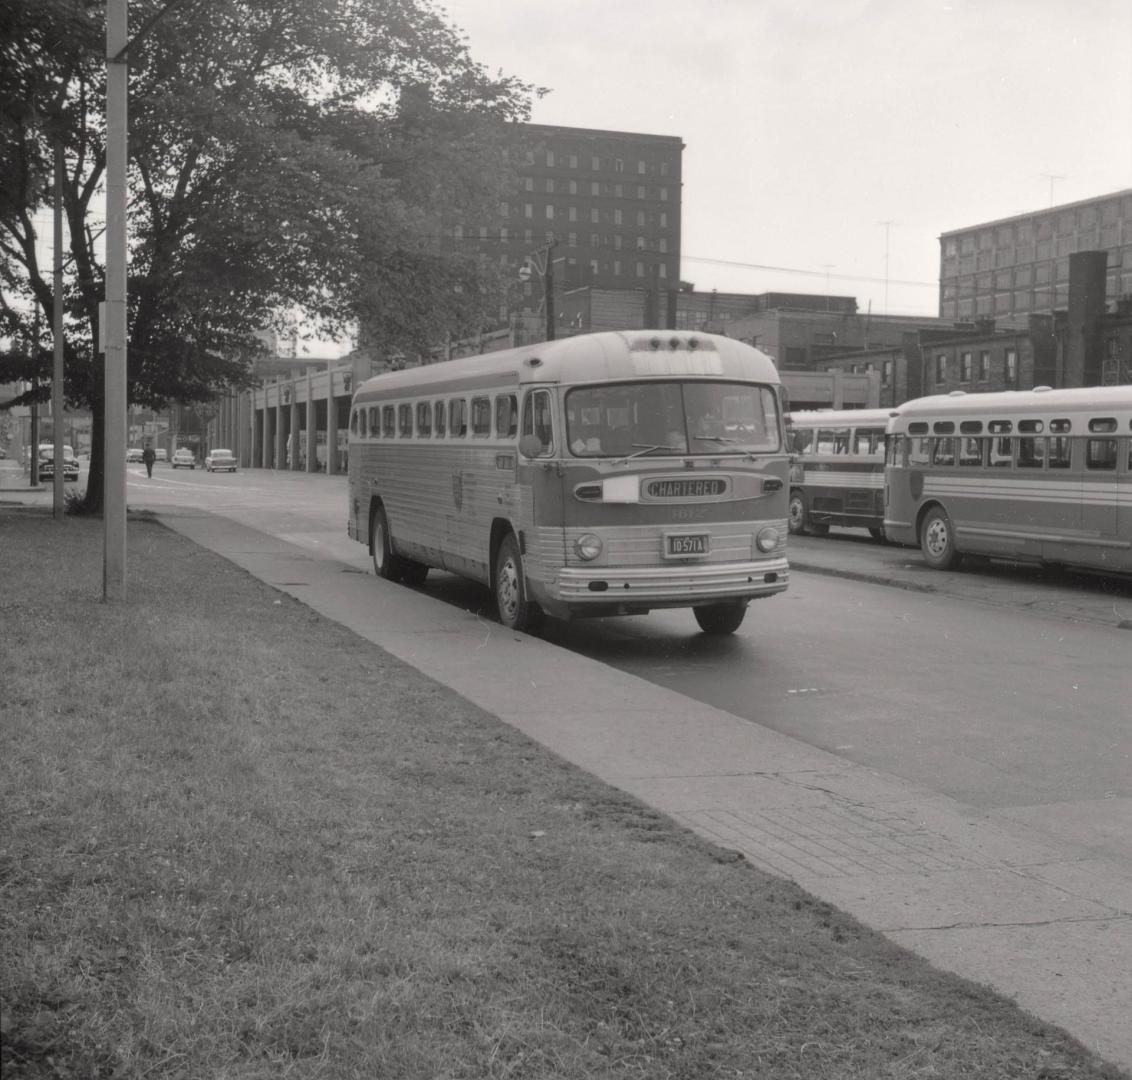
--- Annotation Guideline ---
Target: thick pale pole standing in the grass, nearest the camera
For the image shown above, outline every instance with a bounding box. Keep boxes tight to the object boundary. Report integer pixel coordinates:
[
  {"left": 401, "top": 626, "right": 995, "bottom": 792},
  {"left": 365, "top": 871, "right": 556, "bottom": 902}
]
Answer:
[{"left": 102, "top": 0, "right": 129, "bottom": 601}]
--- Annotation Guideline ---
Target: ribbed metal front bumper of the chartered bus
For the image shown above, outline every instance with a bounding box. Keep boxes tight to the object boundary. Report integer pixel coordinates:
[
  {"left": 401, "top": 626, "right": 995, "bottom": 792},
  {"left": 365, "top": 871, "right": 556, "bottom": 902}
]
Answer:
[{"left": 544, "top": 557, "right": 790, "bottom": 615}]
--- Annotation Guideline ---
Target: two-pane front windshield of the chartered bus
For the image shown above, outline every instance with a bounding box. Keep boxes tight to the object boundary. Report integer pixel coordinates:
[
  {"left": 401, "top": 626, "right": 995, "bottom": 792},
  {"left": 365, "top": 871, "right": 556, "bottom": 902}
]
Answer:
[{"left": 566, "top": 380, "right": 780, "bottom": 457}]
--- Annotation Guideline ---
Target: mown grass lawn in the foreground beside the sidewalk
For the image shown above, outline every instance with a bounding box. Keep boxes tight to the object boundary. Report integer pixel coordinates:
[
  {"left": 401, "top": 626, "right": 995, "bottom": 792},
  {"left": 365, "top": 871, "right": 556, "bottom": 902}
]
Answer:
[{"left": 0, "top": 509, "right": 1121, "bottom": 1080}]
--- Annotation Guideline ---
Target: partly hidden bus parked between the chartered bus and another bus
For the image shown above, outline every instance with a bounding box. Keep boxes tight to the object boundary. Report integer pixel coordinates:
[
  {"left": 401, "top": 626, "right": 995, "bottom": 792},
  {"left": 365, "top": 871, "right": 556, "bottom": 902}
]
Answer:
[{"left": 787, "top": 409, "right": 893, "bottom": 540}]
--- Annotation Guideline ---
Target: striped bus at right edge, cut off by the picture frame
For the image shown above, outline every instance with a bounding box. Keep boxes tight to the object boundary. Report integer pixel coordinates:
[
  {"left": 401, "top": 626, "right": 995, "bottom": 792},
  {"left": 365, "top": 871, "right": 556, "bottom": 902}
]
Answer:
[{"left": 884, "top": 386, "right": 1132, "bottom": 574}]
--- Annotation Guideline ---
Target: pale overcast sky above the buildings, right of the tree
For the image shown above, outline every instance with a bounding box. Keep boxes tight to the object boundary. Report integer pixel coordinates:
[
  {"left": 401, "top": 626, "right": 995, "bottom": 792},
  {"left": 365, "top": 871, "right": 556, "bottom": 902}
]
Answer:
[{"left": 440, "top": 0, "right": 1132, "bottom": 315}]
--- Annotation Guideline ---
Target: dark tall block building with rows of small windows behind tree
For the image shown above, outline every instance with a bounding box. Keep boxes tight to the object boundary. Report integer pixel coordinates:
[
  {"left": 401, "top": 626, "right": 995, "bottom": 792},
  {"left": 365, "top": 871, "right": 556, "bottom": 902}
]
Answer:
[{"left": 453, "top": 123, "right": 684, "bottom": 319}]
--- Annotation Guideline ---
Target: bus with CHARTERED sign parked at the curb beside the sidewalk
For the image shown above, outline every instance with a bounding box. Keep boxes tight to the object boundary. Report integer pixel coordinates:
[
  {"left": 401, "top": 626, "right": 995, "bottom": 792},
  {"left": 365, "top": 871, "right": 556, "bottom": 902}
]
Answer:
[{"left": 348, "top": 331, "right": 789, "bottom": 634}]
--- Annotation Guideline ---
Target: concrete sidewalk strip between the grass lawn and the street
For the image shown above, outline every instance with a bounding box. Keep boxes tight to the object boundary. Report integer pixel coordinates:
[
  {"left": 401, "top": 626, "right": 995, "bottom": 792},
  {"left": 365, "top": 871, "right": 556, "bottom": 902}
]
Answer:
[{"left": 150, "top": 512, "right": 1132, "bottom": 1070}]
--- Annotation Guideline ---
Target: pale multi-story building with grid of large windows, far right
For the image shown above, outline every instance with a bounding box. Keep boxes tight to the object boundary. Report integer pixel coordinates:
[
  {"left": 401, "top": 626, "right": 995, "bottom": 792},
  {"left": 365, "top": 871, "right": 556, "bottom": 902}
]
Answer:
[{"left": 940, "top": 189, "right": 1132, "bottom": 319}]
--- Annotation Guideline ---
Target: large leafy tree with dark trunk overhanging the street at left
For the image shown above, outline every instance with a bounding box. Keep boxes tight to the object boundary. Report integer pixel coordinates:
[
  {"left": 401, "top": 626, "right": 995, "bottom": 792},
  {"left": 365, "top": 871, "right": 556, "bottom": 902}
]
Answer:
[{"left": 0, "top": 0, "right": 538, "bottom": 511}]
